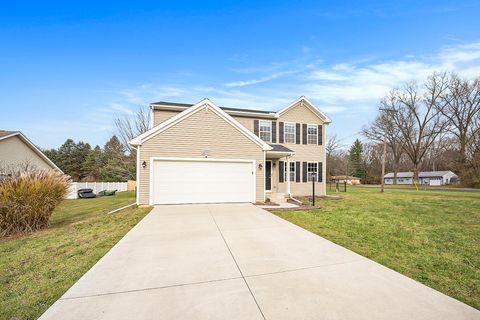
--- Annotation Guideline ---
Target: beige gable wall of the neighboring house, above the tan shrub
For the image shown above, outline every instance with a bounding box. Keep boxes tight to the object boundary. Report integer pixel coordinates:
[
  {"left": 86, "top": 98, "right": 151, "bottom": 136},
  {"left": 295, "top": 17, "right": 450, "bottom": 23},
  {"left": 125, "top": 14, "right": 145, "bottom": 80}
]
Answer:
[{"left": 0, "top": 136, "right": 56, "bottom": 171}]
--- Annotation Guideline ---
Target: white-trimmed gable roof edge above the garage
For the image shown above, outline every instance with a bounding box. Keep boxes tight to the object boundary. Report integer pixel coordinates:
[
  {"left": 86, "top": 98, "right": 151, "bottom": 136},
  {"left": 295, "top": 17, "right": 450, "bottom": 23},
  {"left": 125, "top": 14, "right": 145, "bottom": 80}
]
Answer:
[{"left": 130, "top": 98, "right": 272, "bottom": 150}]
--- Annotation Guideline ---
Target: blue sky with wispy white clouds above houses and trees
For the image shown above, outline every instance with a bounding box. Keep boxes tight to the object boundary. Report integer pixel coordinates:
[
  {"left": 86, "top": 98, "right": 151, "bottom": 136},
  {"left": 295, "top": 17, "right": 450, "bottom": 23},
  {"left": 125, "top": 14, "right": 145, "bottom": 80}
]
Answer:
[{"left": 0, "top": 0, "right": 480, "bottom": 148}]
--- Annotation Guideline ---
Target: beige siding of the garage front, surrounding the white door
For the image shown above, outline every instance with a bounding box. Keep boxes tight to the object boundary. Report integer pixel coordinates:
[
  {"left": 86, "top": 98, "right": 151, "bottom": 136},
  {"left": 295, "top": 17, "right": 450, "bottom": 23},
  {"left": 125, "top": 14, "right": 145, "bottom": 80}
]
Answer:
[{"left": 139, "top": 108, "right": 264, "bottom": 204}]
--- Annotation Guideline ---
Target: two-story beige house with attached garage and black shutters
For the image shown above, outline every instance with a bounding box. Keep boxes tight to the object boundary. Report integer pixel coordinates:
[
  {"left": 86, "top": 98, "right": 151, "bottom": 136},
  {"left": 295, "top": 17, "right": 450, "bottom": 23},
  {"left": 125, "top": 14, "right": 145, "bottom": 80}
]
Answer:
[{"left": 130, "top": 97, "right": 330, "bottom": 204}]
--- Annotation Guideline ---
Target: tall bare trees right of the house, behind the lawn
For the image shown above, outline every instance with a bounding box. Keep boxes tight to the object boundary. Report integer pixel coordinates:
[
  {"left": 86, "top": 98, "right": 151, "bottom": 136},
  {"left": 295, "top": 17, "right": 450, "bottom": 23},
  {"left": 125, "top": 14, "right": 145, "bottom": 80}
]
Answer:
[{"left": 326, "top": 72, "right": 480, "bottom": 187}]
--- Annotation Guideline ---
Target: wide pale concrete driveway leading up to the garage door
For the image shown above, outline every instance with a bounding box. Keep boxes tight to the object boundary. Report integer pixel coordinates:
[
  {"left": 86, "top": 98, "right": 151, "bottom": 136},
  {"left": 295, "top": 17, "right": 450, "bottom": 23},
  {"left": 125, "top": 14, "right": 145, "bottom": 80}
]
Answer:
[{"left": 41, "top": 204, "right": 480, "bottom": 320}]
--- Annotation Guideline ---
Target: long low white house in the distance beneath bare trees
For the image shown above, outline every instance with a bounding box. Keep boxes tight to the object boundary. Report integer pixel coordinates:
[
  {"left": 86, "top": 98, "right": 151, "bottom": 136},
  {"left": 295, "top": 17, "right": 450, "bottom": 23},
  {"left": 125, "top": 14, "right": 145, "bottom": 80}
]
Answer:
[{"left": 383, "top": 171, "right": 458, "bottom": 186}]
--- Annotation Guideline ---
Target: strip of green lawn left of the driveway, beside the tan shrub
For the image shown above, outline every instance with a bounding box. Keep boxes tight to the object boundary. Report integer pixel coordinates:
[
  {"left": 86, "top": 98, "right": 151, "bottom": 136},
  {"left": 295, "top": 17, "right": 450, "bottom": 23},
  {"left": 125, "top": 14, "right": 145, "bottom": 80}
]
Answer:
[{"left": 0, "top": 192, "right": 151, "bottom": 320}]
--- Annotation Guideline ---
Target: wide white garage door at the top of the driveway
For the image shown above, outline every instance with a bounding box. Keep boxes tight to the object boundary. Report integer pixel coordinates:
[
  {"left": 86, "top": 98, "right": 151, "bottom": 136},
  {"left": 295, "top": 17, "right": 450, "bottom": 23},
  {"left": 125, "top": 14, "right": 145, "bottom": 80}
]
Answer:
[{"left": 152, "top": 159, "right": 255, "bottom": 204}]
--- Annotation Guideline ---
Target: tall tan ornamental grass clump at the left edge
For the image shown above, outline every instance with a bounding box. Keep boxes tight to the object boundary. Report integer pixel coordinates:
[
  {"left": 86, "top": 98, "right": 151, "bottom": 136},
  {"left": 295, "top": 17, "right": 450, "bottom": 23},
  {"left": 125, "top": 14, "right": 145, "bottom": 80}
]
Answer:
[{"left": 0, "top": 170, "right": 70, "bottom": 236}]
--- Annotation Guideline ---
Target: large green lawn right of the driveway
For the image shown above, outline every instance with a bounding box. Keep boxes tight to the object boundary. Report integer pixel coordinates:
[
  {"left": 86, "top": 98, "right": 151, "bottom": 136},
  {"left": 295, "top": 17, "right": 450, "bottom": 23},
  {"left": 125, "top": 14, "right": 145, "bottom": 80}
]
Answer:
[{"left": 275, "top": 188, "right": 480, "bottom": 309}]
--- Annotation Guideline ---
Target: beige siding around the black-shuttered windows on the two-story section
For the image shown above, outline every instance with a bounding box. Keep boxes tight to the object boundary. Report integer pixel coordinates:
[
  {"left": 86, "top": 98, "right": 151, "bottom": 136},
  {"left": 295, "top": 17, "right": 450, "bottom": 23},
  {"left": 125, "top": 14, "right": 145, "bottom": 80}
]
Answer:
[{"left": 272, "top": 103, "right": 326, "bottom": 196}]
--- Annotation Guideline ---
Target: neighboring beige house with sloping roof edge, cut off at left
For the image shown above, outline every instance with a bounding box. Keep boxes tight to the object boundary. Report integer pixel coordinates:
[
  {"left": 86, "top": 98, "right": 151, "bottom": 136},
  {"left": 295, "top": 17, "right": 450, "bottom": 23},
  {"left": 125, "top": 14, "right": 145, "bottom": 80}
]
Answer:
[{"left": 0, "top": 130, "right": 61, "bottom": 173}]
